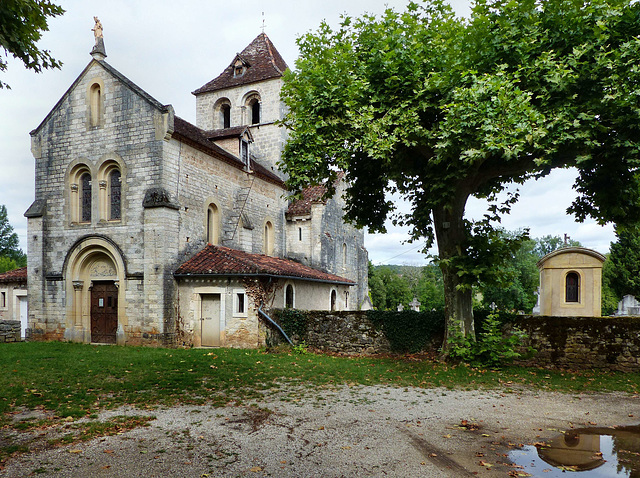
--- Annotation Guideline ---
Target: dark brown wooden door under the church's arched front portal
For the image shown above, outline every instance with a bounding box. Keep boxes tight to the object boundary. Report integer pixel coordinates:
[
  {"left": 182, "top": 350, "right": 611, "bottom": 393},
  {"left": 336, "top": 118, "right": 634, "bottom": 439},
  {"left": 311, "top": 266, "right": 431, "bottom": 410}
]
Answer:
[{"left": 91, "top": 282, "right": 118, "bottom": 344}]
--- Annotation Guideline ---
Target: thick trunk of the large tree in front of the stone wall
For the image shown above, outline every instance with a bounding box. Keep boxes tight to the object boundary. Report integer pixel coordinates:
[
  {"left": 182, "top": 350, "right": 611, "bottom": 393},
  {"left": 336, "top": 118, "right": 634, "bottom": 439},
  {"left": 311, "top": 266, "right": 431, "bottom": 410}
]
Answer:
[{"left": 433, "top": 193, "right": 475, "bottom": 353}]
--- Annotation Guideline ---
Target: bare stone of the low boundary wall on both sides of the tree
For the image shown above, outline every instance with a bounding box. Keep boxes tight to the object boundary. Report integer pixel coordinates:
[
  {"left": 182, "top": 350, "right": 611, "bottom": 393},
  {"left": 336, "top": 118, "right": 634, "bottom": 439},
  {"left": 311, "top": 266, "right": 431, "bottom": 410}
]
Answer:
[{"left": 267, "top": 310, "right": 640, "bottom": 372}]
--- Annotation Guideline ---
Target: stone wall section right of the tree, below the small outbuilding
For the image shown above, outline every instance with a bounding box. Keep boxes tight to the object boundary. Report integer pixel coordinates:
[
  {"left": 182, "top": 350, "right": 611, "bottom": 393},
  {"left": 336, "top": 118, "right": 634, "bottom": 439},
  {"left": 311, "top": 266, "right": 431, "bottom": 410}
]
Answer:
[{"left": 518, "top": 317, "right": 640, "bottom": 371}]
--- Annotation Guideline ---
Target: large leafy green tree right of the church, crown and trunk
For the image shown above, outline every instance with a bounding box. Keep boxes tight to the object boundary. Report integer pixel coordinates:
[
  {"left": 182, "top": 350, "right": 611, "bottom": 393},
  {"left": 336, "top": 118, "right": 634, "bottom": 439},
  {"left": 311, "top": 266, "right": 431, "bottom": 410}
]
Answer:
[{"left": 282, "top": 0, "right": 640, "bottom": 346}]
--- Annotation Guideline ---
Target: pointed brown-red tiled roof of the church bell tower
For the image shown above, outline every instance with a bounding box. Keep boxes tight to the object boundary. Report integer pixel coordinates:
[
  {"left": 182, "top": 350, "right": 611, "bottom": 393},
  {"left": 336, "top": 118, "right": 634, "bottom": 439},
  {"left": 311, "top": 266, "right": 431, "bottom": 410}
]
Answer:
[{"left": 193, "top": 33, "right": 288, "bottom": 95}]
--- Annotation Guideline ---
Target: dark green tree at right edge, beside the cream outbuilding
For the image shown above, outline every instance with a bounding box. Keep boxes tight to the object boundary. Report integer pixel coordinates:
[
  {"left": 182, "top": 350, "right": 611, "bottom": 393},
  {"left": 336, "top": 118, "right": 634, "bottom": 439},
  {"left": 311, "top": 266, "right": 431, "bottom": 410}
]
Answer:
[{"left": 603, "top": 226, "right": 640, "bottom": 299}]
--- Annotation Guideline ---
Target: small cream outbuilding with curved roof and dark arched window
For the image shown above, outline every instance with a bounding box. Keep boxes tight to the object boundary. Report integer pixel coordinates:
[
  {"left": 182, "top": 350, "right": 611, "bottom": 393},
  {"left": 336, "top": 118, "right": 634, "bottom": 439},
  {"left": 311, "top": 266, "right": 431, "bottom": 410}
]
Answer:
[{"left": 537, "top": 247, "right": 605, "bottom": 317}]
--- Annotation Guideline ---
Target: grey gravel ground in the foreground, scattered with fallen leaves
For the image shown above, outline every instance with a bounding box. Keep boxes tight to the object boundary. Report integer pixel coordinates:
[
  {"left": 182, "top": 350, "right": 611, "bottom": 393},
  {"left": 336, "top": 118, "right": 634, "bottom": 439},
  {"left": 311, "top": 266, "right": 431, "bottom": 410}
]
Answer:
[{"left": 0, "top": 386, "right": 640, "bottom": 478}]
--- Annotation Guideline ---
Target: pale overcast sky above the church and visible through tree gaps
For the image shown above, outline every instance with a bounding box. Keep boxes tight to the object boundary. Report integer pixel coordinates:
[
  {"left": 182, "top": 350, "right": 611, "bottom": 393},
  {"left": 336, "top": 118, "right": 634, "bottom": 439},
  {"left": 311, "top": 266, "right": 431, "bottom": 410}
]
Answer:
[{"left": 0, "top": 0, "right": 615, "bottom": 265}]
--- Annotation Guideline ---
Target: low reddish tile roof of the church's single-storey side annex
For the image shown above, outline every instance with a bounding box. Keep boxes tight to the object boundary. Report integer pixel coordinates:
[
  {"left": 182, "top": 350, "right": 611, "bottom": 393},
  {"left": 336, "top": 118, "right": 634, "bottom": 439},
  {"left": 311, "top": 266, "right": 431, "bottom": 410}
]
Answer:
[{"left": 174, "top": 244, "right": 355, "bottom": 285}]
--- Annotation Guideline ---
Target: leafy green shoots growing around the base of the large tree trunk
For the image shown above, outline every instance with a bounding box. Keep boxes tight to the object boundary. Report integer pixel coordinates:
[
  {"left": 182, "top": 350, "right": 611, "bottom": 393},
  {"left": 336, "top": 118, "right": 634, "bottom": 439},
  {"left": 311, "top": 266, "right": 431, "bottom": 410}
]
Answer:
[{"left": 447, "top": 314, "right": 527, "bottom": 368}]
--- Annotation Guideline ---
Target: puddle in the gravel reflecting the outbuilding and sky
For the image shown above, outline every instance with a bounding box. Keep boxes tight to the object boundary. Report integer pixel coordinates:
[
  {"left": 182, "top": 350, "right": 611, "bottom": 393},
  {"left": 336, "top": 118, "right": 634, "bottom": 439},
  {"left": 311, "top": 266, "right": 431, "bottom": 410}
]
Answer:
[{"left": 509, "top": 426, "right": 640, "bottom": 478}]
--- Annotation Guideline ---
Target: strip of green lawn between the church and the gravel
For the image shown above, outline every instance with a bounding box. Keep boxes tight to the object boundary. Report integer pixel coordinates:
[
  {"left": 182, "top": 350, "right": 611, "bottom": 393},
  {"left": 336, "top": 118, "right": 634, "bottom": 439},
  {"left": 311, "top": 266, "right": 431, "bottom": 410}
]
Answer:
[{"left": 0, "top": 342, "right": 640, "bottom": 420}]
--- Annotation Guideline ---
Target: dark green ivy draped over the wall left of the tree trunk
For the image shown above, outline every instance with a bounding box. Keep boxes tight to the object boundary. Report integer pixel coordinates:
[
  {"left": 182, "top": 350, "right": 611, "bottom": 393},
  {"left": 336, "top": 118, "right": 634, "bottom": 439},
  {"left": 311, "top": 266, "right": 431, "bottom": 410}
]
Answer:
[{"left": 367, "top": 310, "right": 444, "bottom": 353}]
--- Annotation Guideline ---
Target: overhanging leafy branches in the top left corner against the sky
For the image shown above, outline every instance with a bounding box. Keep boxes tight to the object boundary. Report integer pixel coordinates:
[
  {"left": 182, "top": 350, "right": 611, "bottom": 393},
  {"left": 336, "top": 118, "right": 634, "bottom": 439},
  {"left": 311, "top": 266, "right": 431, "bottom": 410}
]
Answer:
[{"left": 0, "top": 0, "right": 64, "bottom": 88}]
